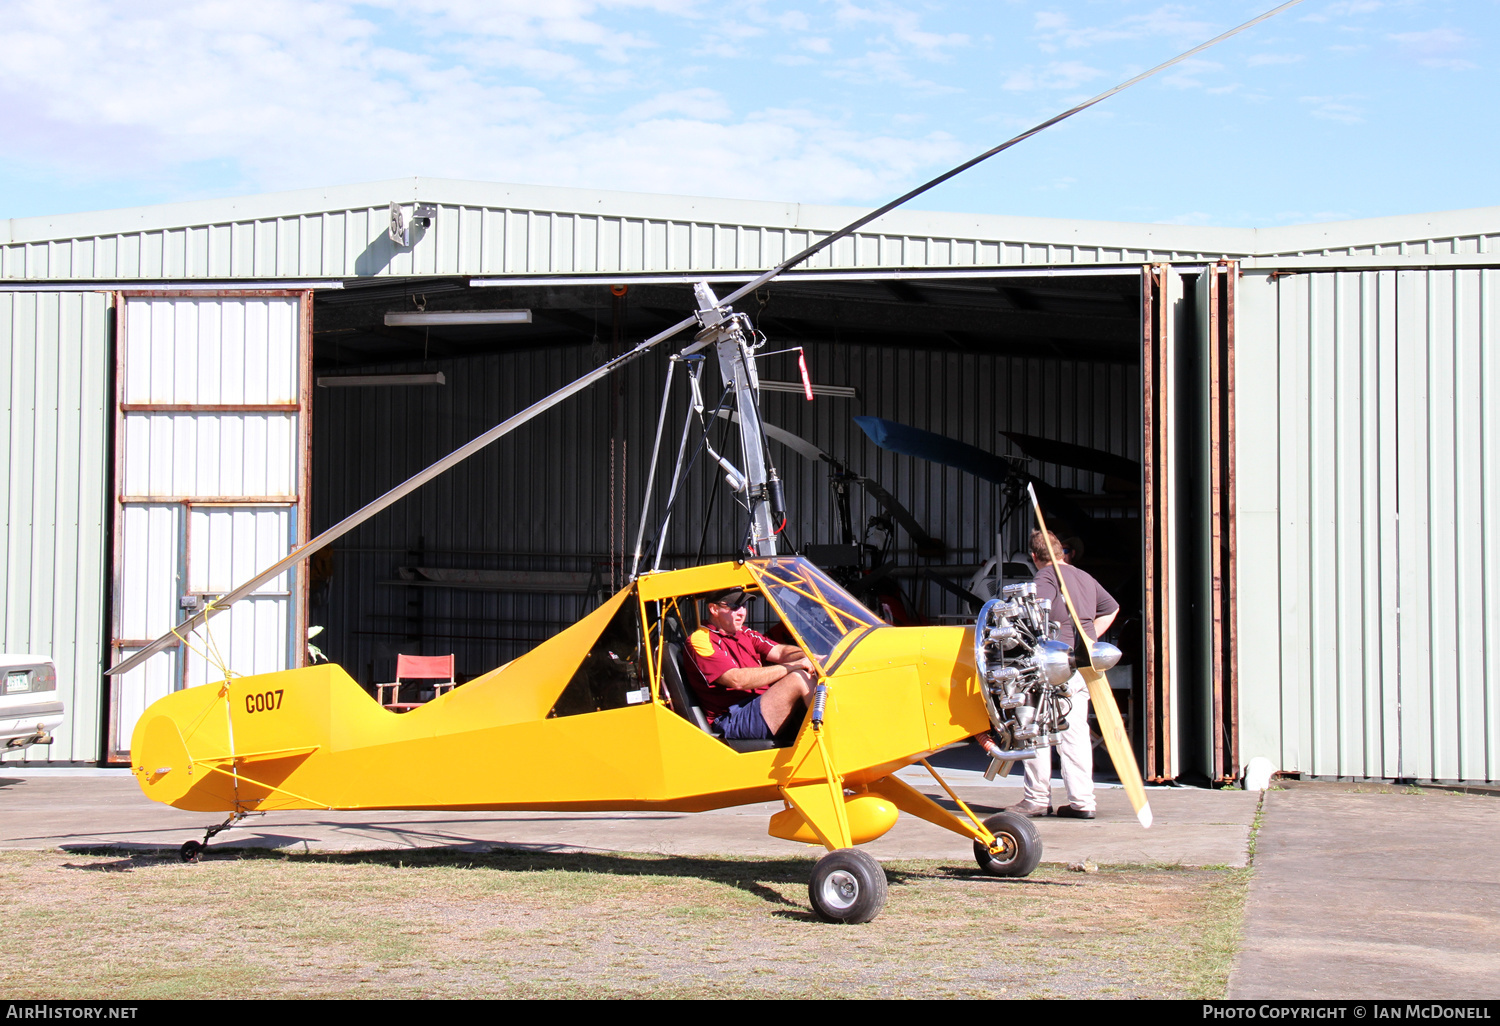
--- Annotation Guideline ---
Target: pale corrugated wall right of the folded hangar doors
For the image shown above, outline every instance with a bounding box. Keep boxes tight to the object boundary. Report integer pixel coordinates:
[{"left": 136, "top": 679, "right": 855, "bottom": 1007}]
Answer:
[{"left": 1241, "top": 269, "right": 1500, "bottom": 780}]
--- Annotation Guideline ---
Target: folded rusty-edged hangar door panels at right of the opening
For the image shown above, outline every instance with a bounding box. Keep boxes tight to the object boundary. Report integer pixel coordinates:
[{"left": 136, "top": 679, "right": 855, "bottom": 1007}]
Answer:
[{"left": 1140, "top": 261, "right": 1242, "bottom": 783}]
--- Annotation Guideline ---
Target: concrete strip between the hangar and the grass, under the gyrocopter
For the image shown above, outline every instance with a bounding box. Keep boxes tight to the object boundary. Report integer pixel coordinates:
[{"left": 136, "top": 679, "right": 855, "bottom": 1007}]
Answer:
[{"left": 0, "top": 765, "right": 1259, "bottom": 866}]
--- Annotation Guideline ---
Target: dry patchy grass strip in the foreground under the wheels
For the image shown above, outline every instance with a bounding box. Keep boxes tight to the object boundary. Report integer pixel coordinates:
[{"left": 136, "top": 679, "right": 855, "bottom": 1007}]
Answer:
[{"left": 0, "top": 849, "right": 1248, "bottom": 999}]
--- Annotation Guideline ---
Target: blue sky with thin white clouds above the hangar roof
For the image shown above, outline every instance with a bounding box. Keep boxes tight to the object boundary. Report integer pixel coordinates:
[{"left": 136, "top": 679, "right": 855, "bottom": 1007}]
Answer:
[{"left": 0, "top": 0, "right": 1500, "bottom": 227}]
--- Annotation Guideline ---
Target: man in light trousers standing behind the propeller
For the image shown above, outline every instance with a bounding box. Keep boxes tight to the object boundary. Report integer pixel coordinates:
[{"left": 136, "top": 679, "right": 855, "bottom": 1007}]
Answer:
[{"left": 1011, "top": 531, "right": 1121, "bottom": 819}]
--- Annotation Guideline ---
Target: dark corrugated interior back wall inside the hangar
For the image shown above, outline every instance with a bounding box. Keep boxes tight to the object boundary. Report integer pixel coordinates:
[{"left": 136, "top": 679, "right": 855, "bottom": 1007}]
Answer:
[{"left": 312, "top": 341, "right": 1140, "bottom": 683}]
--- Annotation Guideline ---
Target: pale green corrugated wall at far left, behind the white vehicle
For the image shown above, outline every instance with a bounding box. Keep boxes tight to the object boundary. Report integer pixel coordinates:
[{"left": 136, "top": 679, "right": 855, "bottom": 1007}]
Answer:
[{"left": 0, "top": 293, "right": 110, "bottom": 762}]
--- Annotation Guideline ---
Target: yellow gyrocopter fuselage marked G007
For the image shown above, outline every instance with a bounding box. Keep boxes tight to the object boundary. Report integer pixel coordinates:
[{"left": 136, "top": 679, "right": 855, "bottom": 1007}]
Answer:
[{"left": 131, "top": 564, "right": 990, "bottom": 840}]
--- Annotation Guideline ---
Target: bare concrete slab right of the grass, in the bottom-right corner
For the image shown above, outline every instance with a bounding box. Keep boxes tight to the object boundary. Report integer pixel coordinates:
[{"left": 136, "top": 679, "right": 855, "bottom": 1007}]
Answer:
[{"left": 1229, "top": 782, "right": 1500, "bottom": 1001}]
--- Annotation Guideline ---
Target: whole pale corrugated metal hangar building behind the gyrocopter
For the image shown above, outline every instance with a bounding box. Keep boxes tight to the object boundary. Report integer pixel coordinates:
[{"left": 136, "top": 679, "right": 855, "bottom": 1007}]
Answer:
[{"left": 0, "top": 179, "right": 1500, "bottom": 783}]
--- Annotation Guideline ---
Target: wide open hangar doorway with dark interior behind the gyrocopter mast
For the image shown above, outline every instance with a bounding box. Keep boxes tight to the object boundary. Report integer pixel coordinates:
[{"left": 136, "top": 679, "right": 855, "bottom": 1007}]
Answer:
[{"left": 301, "top": 269, "right": 1233, "bottom": 780}]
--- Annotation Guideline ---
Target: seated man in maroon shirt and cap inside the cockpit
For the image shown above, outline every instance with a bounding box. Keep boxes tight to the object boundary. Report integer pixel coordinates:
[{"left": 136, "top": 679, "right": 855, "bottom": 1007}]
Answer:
[{"left": 683, "top": 588, "right": 813, "bottom": 741}]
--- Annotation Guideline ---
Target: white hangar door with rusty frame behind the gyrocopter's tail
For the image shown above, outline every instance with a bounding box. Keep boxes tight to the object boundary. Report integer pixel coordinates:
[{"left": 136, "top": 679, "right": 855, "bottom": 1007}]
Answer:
[{"left": 108, "top": 291, "right": 312, "bottom": 761}]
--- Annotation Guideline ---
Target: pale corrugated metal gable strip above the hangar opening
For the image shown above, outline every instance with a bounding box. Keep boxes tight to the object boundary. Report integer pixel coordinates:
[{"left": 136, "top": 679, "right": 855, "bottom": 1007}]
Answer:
[{"left": 0, "top": 204, "right": 1218, "bottom": 281}]
